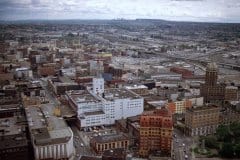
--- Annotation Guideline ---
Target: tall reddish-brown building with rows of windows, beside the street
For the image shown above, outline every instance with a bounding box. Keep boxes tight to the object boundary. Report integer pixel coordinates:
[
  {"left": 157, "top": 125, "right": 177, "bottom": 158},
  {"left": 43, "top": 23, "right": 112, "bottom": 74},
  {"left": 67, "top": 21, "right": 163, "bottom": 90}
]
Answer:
[{"left": 139, "top": 107, "right": 173, "bottom": 157}]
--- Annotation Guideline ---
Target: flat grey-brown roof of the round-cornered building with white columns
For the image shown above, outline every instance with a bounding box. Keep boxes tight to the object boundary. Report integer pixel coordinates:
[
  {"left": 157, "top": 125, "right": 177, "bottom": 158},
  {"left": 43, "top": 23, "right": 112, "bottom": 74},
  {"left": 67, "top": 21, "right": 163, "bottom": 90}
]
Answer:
[{"left": 26, "top": 104, "right": 72, "bottom": 145}]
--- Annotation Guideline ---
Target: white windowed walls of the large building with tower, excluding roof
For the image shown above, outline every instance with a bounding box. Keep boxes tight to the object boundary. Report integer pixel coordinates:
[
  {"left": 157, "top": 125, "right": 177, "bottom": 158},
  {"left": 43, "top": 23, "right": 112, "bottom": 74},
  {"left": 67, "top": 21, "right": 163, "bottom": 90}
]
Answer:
[{"left": 74, "top": 94, "right": 143, "bottom": 127}]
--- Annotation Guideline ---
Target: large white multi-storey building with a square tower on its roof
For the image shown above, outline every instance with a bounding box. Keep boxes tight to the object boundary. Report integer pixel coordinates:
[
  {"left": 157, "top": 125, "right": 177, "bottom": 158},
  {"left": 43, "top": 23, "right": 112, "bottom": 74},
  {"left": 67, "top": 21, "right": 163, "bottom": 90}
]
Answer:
[{"left": 66, "top": 78, "right": 143, "bottom": 127}]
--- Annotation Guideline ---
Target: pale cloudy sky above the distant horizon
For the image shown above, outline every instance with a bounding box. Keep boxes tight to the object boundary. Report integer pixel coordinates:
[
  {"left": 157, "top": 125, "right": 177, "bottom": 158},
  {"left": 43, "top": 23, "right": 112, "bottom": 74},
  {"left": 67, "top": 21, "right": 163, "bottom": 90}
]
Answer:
[{"left": 0, "top": 0, "right": 240, "bottom": 22}]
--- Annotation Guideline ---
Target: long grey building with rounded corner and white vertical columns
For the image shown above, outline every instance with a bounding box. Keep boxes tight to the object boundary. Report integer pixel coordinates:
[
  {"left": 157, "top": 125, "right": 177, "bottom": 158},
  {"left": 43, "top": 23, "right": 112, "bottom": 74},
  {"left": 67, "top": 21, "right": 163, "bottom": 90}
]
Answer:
[{"left": 25, "top": 104, "right": 74, "bottom": 160}]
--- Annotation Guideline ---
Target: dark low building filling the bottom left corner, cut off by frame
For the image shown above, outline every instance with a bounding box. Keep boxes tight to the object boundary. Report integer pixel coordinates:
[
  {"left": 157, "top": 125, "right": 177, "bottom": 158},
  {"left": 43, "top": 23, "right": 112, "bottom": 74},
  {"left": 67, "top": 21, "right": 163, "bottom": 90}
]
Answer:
[{"left": 0, "top": 104, "right": 31, "bottom": 160}]
